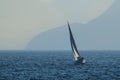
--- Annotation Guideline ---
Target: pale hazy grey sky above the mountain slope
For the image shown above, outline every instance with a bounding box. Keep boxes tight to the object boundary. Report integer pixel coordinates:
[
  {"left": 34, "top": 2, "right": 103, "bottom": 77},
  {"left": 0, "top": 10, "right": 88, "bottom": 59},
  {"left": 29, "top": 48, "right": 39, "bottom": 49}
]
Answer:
[{"left": 0, "top": 0, "right": 114, "bottom": 50}]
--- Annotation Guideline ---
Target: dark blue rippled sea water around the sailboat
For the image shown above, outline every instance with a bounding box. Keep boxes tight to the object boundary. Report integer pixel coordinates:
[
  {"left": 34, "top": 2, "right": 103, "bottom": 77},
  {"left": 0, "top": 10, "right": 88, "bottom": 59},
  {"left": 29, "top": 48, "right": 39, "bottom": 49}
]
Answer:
[{"left": 0, "top": 51, "right": 120, "bottom": 80}]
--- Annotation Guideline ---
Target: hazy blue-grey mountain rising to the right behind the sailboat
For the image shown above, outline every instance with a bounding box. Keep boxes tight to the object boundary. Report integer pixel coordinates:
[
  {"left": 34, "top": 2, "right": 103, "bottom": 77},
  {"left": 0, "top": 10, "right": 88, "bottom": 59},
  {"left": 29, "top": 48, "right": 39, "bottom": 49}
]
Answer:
[{"left": 26, "top": 0, "right": 120, "bottom": 50}]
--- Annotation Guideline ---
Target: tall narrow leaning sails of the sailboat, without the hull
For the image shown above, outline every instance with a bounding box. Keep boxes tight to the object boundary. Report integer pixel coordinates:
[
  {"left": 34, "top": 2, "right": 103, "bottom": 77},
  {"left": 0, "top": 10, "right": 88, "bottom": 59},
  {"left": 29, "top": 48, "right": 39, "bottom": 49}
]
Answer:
[{"left": 68, "top": 22, "right": 80, "bottom": 61}]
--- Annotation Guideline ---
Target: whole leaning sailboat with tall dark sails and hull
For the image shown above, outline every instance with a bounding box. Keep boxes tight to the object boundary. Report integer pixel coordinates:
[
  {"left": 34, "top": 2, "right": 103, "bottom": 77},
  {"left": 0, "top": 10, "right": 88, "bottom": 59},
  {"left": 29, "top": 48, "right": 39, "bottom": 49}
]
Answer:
[{"left": 67, "top": 22, "right": 86, "bottom": 65}]
